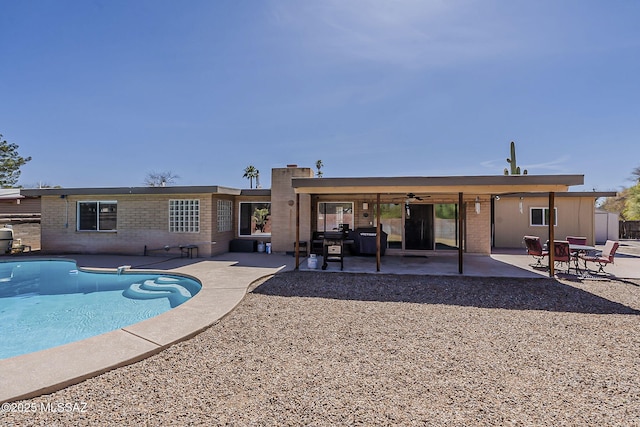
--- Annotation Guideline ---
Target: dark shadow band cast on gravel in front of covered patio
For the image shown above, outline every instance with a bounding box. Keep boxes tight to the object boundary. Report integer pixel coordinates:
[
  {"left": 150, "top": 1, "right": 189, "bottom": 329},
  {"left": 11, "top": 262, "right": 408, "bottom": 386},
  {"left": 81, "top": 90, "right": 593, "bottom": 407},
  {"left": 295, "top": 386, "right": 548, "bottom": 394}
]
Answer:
[{"left": 252, "top": 272, "right": 640, "bottom": 315}]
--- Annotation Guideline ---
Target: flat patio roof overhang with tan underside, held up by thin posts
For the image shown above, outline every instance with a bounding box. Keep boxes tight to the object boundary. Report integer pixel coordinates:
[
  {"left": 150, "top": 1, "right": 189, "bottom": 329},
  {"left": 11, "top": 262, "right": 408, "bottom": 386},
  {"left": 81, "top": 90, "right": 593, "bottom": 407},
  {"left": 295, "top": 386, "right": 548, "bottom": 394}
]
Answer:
[{"left": 291, "top": 175, "right": 584, "bottom": 195}]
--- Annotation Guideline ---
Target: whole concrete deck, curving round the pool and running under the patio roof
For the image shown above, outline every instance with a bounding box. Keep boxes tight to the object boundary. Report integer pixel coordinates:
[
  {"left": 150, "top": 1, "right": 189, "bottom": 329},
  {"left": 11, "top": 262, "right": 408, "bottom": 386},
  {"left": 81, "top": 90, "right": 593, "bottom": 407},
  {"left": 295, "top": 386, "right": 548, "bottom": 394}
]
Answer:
[{"left": 0, "top": 242, "right": 640, "bottom": 403}]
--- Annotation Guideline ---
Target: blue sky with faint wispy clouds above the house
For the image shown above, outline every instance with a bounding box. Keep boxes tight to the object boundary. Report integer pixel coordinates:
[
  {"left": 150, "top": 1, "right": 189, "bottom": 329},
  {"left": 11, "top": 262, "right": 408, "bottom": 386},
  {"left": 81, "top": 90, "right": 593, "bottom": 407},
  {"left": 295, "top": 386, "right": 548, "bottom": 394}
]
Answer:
[{"left": 0, "top": 0, "right": 640, "bottom": 191}]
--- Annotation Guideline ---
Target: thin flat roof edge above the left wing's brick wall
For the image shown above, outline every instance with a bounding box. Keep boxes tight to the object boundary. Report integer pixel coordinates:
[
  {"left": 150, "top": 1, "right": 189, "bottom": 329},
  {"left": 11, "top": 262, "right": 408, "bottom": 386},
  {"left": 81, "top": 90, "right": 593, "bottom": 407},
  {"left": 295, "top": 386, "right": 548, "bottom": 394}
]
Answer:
[{"left": 21, "top": 185, "right": 241, "bottom": 196}]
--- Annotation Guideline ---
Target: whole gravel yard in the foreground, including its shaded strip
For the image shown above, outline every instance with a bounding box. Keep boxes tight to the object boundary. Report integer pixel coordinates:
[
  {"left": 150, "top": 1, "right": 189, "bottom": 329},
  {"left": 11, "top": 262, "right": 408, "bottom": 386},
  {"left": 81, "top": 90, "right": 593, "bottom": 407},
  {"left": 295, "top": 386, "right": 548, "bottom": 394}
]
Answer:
[{"left": 0, "top": 272, "right": 640, "bottom": 426}]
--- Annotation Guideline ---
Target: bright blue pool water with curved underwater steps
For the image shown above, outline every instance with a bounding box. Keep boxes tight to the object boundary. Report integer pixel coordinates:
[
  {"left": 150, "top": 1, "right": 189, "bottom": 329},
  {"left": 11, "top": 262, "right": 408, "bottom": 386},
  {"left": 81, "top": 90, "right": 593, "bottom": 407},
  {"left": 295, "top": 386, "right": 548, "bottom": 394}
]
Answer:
[{"left": 0, "top": 260, "right": 201, "bottom": 359}]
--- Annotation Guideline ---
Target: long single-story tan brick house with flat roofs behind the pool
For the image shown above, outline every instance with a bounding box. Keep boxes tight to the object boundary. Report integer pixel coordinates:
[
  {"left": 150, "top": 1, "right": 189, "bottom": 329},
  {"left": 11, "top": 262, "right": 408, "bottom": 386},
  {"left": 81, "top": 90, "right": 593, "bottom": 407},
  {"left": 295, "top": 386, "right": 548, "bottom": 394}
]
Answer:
[{"left": 17, "top": 165, "right": 615, "bottom": 268}]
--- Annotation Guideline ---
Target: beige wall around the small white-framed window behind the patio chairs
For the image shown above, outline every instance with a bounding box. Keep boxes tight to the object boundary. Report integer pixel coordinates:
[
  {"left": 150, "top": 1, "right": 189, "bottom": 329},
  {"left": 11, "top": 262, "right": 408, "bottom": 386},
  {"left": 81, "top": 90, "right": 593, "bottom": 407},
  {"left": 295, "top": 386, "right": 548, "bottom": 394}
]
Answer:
[{"left": 495, "top": 195, "right": 595, "bottom": 248}]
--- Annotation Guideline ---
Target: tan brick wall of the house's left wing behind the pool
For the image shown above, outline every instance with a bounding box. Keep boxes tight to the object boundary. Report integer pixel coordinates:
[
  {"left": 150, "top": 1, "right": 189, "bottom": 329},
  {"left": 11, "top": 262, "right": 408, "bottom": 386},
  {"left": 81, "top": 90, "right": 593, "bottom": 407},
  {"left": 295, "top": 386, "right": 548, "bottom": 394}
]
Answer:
[{"left": 41, "top": 194, "right": 233, "bottom": 257}]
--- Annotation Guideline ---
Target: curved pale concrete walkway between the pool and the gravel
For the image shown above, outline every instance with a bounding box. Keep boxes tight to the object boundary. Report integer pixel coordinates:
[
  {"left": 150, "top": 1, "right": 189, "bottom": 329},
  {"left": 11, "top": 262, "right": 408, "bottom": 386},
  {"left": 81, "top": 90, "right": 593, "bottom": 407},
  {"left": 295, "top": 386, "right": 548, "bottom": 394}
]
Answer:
[{"left": 0, "top": 257, "right": 287, "bottom": 403}]
